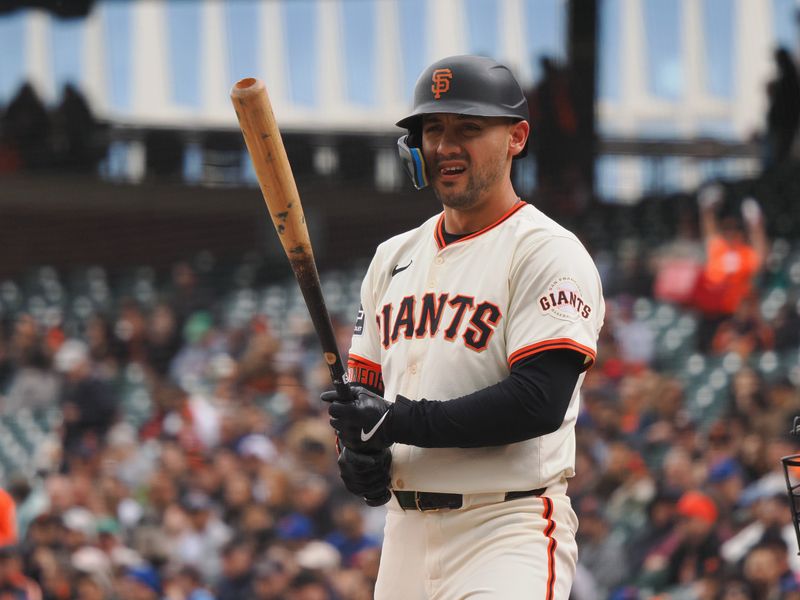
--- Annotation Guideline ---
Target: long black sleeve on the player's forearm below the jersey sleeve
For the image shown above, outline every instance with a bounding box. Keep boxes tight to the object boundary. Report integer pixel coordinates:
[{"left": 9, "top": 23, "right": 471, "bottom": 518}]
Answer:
[{"left": 389, "top": 350, "right": 584, "bottom": 448}]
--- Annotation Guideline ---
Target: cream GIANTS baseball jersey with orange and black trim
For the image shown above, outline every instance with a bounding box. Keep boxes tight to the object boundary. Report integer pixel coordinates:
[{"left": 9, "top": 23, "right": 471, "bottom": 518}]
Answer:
[{"left": 348, "top": 201, "right": 605, "bottom": 494}]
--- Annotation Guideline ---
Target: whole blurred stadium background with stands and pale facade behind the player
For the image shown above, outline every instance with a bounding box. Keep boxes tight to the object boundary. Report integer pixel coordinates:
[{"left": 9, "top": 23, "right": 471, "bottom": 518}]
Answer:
[{"left": 0, "top": 0, "right": 800, "bottom": 600}]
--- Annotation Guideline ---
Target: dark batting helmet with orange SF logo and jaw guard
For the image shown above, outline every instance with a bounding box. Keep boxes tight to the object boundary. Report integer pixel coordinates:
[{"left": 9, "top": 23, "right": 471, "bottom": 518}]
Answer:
[{"left": 397, "top": 55, "right": 530, "bottom": 189}]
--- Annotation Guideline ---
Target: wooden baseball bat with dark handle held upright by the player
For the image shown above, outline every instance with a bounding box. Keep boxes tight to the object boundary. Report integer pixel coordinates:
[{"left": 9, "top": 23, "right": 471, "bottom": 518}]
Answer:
[{"left": 231, "top": 78, "right": 391, "bottom": 506}]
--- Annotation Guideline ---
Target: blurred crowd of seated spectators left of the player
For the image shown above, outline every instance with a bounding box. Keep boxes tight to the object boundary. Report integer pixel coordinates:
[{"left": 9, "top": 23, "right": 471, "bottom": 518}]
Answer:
[{"left": 0, "top": 264, "right": 382, "bottom": 600}]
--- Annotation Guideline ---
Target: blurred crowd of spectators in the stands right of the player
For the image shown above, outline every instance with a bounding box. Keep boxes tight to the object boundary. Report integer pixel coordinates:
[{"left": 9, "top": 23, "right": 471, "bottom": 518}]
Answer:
[{"left": 570, "top": 184, "right": 800, "bottom": 600}]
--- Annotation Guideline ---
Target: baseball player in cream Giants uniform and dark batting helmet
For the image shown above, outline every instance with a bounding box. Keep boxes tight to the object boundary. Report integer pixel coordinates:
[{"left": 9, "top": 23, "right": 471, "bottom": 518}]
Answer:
[{"left": 323, "top": 56, "right": 604, "bottom": 600}]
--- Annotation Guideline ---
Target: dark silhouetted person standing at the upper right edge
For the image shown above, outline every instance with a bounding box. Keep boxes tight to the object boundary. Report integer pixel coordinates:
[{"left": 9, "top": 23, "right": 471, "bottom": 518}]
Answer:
[{"left": 764, "top": 48, "right": 800, "bottom": 171}]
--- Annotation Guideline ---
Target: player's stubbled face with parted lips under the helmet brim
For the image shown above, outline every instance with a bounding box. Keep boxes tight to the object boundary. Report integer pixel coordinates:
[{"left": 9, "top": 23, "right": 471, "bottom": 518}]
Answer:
[{"left": 422, "top": 114, "right": 527, "bottom": 210}]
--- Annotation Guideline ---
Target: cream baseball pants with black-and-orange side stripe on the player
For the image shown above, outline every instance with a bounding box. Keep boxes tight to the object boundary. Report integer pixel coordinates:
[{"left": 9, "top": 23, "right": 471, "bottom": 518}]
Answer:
[{"left": 375, "top": 483, "right": 578, "bottom": 600}]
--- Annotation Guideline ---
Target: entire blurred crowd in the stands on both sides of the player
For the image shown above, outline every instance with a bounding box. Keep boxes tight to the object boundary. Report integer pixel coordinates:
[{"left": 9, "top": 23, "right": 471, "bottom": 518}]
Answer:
[{"left": 0, "top": 186, "right": 800, "bottom": 600}]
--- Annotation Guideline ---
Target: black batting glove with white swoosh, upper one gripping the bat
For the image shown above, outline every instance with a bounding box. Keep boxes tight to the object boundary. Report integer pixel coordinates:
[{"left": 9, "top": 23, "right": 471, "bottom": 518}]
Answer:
[{"left": 320, "top": 386, "right": 394, "bottom": 452}]
